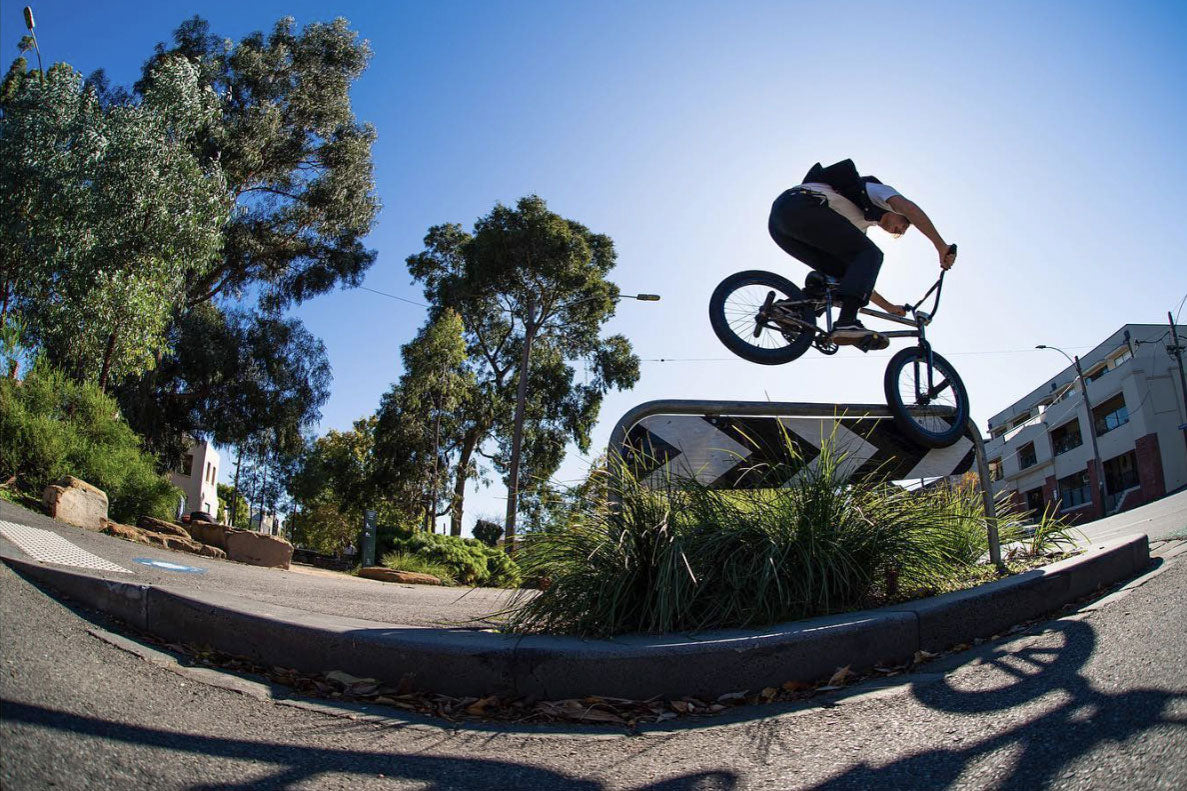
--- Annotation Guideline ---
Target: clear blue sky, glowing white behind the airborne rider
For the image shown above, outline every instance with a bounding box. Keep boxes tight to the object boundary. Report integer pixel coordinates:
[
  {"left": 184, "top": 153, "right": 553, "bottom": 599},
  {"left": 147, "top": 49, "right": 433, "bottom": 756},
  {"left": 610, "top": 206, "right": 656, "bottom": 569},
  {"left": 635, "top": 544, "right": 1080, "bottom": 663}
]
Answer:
[{"left": 0, "top": 0, "right": 1187, "bottom": 532}]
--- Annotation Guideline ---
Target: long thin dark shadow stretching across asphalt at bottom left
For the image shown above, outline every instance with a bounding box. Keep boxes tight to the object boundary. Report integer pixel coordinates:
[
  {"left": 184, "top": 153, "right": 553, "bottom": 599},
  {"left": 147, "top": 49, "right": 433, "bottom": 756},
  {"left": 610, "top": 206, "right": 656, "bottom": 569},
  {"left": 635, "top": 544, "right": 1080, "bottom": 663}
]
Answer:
[{"left": 0, "top": 700, "right": 738, "bottom": 791}]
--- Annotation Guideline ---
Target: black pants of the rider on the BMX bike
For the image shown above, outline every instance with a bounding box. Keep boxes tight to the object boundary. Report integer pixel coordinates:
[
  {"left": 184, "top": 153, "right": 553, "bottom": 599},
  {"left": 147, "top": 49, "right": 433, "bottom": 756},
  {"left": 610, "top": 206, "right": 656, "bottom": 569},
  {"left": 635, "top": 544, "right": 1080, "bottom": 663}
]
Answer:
[{"left": 767, "top": 190, "right": 882, "bottom": 312}]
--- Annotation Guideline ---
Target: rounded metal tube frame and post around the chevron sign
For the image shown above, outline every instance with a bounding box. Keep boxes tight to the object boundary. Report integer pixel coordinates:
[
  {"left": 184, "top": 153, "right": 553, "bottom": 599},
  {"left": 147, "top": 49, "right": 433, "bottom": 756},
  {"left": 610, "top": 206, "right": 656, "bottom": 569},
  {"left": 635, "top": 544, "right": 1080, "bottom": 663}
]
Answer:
[{"left": 607, "top": 399, "right": 1002, "bottom": 567}]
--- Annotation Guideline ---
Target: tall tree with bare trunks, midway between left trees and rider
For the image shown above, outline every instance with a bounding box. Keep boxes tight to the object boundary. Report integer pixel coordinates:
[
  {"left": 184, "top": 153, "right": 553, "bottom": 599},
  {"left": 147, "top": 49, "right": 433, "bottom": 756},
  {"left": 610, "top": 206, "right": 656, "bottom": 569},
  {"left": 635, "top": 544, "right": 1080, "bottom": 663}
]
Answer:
[{"left": 408, "top": 196, "right": 639, "bottom": 545}]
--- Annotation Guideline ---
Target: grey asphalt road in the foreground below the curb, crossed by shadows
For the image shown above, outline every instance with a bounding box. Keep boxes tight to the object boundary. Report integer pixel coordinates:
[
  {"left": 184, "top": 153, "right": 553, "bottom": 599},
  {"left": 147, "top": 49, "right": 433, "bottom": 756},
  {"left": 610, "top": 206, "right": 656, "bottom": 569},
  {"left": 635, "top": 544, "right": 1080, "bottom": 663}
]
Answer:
[{"left": 0, "top": 532, "right": 1187, "bottom": 791}]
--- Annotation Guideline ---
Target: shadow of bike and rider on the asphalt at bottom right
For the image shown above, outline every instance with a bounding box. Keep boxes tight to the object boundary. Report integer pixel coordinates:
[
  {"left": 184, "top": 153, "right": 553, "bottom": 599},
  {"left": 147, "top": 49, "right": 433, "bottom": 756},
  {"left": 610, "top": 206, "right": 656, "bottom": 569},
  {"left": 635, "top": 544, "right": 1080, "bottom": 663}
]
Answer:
[{"left": 812, "top": 621, "right": 1187, "bottom": 791}]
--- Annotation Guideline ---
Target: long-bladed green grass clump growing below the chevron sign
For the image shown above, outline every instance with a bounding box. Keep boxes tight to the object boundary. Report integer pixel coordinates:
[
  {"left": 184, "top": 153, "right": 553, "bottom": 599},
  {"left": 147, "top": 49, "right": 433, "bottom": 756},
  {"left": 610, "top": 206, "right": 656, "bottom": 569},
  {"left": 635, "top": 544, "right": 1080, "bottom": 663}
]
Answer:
[{"left": 508, "top": 427, "right": 1011, "bottom": 637}]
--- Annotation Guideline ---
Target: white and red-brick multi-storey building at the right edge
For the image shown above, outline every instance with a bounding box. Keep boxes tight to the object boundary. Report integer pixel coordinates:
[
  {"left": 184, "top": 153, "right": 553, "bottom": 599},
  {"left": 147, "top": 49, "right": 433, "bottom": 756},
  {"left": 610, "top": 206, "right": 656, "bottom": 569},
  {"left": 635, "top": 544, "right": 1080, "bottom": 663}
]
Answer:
[{"left": 985, "top": 324, "right": 1187, "bottom": 521}]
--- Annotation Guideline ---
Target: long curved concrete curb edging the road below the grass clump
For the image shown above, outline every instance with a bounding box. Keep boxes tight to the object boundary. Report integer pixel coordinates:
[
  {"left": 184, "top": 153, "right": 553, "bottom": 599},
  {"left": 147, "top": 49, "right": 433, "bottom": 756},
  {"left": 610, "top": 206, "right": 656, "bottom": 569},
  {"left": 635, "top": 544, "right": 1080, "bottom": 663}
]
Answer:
[{"left": 4, "top": 534, "right": 1150, "bottom": 700}]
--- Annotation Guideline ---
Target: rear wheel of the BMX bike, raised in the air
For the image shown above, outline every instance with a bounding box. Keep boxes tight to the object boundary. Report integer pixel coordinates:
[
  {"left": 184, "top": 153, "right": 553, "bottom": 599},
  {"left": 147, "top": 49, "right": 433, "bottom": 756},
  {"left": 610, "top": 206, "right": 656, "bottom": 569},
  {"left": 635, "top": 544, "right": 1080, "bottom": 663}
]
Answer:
[{"left": 709, "top": 270, "right": 815, "bottom": 366}]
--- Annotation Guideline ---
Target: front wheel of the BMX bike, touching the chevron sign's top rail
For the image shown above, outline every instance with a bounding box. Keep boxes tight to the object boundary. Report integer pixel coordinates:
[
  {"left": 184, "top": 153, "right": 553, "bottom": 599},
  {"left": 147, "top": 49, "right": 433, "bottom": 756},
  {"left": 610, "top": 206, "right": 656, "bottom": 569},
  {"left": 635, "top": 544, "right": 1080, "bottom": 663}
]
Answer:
[{"left": 882, "top": 346, "right": 969, "bottom": 448}]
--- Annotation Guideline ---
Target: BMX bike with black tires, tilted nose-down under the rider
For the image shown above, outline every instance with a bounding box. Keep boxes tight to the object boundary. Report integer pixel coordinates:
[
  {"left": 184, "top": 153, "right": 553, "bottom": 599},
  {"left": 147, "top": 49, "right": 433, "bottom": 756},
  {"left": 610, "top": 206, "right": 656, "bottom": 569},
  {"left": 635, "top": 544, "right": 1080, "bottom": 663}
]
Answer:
[{"left": 709, "top": 252, "right": 969, "bottom": 448}]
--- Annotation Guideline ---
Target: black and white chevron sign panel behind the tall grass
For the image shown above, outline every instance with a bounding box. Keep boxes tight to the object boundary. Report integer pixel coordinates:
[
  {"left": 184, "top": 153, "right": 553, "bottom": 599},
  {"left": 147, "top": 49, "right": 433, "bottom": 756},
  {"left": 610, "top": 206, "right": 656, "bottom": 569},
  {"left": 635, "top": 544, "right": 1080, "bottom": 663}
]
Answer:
[{"left": 621, "top": 415, "right": 976, "bottom": 489}]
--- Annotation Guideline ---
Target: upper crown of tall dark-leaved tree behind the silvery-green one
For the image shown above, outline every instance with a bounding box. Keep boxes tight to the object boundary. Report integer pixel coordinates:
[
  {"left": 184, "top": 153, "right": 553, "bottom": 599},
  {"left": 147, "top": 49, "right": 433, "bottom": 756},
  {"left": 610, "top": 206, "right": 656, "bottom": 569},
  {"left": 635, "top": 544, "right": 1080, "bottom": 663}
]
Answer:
[{"left": 135, "top": 17, "right": 379, "bottom": 311}]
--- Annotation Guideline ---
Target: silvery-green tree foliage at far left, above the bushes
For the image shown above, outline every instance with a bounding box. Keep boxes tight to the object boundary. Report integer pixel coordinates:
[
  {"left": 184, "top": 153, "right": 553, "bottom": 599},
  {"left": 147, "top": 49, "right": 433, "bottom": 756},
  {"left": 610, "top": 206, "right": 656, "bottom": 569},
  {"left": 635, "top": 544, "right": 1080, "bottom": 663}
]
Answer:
[{"left": 0, "top": 57, "right": 230, "bottom": 387}]
